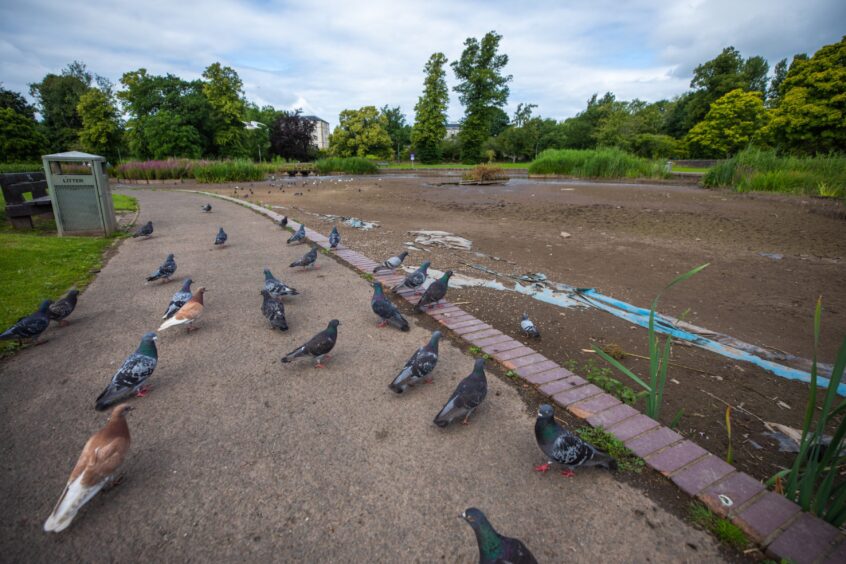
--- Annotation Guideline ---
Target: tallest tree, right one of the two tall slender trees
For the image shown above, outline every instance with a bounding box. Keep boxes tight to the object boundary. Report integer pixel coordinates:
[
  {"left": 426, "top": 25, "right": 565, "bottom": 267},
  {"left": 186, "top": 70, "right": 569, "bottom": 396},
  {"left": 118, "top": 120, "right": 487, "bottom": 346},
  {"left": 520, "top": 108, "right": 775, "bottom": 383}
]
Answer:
[{"left": 452, "top": 31, "right": 512, "bottom": 163}]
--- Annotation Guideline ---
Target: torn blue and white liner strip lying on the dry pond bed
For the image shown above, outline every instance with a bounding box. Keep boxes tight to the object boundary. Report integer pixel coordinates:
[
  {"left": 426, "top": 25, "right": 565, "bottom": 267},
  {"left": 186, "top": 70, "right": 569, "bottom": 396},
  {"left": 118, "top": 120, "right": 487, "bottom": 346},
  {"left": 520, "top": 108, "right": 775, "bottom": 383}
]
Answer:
[{"left": 410, "top": 264, "right": 846, "bottom": 396}]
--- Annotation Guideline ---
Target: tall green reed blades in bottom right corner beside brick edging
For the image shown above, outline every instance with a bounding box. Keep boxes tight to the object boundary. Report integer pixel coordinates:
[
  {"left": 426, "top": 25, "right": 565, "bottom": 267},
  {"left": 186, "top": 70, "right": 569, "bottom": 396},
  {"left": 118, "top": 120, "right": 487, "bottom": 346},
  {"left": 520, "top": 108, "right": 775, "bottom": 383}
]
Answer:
[{"left": 769, "top": 298, "right": 846, "bottom": 527}]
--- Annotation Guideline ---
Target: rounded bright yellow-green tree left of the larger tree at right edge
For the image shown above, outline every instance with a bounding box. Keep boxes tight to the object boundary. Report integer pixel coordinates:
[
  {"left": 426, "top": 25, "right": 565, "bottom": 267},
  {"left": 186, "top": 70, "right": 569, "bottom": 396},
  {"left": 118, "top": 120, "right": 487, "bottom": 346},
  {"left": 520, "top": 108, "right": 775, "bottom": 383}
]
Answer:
[{"left": 686, "top": 88, "right": 766, "bottom": 159}]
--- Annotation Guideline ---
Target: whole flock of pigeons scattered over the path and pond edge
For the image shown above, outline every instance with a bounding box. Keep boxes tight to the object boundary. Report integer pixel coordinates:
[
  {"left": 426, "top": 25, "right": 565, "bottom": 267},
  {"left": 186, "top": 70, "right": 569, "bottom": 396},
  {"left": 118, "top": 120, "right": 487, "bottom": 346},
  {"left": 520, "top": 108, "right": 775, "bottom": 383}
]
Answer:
[{"left": 0, "top": 198, "right": 617, "bottom": 563}]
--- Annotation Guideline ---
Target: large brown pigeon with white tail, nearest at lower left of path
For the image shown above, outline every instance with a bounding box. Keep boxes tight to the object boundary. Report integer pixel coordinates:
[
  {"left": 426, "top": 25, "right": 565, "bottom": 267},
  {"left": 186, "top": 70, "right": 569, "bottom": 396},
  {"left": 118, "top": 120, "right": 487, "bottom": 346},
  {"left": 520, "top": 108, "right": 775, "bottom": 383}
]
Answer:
[{"left": 44, "top": 404, "right": 132, "bottom": 533}]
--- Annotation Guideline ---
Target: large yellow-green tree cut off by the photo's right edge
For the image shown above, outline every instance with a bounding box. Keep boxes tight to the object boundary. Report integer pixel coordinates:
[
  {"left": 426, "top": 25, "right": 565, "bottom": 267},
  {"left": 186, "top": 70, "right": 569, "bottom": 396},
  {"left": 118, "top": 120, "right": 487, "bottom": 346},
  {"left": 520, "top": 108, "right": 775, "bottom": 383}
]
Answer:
[{"left": 763, "top": 37, "right": 846, "bottom": 154}]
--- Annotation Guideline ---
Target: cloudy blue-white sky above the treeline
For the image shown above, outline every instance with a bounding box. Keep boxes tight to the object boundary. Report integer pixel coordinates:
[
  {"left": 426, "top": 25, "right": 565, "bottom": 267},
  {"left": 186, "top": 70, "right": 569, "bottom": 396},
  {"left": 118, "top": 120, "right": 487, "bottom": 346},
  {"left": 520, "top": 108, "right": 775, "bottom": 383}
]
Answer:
[{"left": 0, "top": 0, "right": 846, "bottom": 126}]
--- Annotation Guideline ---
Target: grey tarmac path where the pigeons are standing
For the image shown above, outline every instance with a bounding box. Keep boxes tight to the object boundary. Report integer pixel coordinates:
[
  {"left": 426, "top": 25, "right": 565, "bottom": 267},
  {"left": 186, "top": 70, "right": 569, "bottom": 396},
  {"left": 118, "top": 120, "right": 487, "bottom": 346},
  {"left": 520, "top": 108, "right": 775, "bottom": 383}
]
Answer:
[{"left": 0, "top": 190, "right": 722, "bottom": 562}]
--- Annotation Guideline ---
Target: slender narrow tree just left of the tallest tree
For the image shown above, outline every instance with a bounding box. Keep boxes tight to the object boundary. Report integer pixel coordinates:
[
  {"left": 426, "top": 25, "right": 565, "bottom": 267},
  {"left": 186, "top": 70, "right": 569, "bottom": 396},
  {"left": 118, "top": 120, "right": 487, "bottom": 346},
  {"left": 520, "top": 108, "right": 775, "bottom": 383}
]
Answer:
[{"left": 411, "top": 53, "right": 449, "bottom": 163}]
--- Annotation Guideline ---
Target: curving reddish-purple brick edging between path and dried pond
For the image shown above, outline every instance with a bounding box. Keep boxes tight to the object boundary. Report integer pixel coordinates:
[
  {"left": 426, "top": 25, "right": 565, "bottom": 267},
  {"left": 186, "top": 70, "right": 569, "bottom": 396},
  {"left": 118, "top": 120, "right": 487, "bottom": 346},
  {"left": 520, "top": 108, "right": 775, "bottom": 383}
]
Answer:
[{"left": 192, "top": 190, "right": 846, "bottom": 564}]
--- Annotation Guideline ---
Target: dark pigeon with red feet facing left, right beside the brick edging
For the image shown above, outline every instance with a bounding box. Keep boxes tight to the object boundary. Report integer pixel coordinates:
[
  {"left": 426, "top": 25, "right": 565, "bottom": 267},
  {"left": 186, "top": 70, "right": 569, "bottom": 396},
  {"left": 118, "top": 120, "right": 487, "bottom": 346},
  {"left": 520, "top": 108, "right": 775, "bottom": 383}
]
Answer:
[{"left": 535, "top": 403, "right": 617, "bottom": 478}]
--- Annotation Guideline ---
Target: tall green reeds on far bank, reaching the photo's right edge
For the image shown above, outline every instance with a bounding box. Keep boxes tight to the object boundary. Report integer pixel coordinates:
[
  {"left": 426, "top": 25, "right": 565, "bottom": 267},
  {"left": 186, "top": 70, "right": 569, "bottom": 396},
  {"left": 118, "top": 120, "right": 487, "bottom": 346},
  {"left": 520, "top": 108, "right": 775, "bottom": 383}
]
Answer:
[{"left": 702, "top": 148, "right": 846, "bottom": 198}]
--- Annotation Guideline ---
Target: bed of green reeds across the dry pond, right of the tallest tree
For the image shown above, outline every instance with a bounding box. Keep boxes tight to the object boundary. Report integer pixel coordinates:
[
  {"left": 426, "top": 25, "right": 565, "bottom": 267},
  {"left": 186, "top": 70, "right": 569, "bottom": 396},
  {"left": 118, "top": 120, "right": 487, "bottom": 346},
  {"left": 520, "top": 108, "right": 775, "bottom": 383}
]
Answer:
[{"left": 529, "top": 148, "right": 667, "bottom": 178}]
